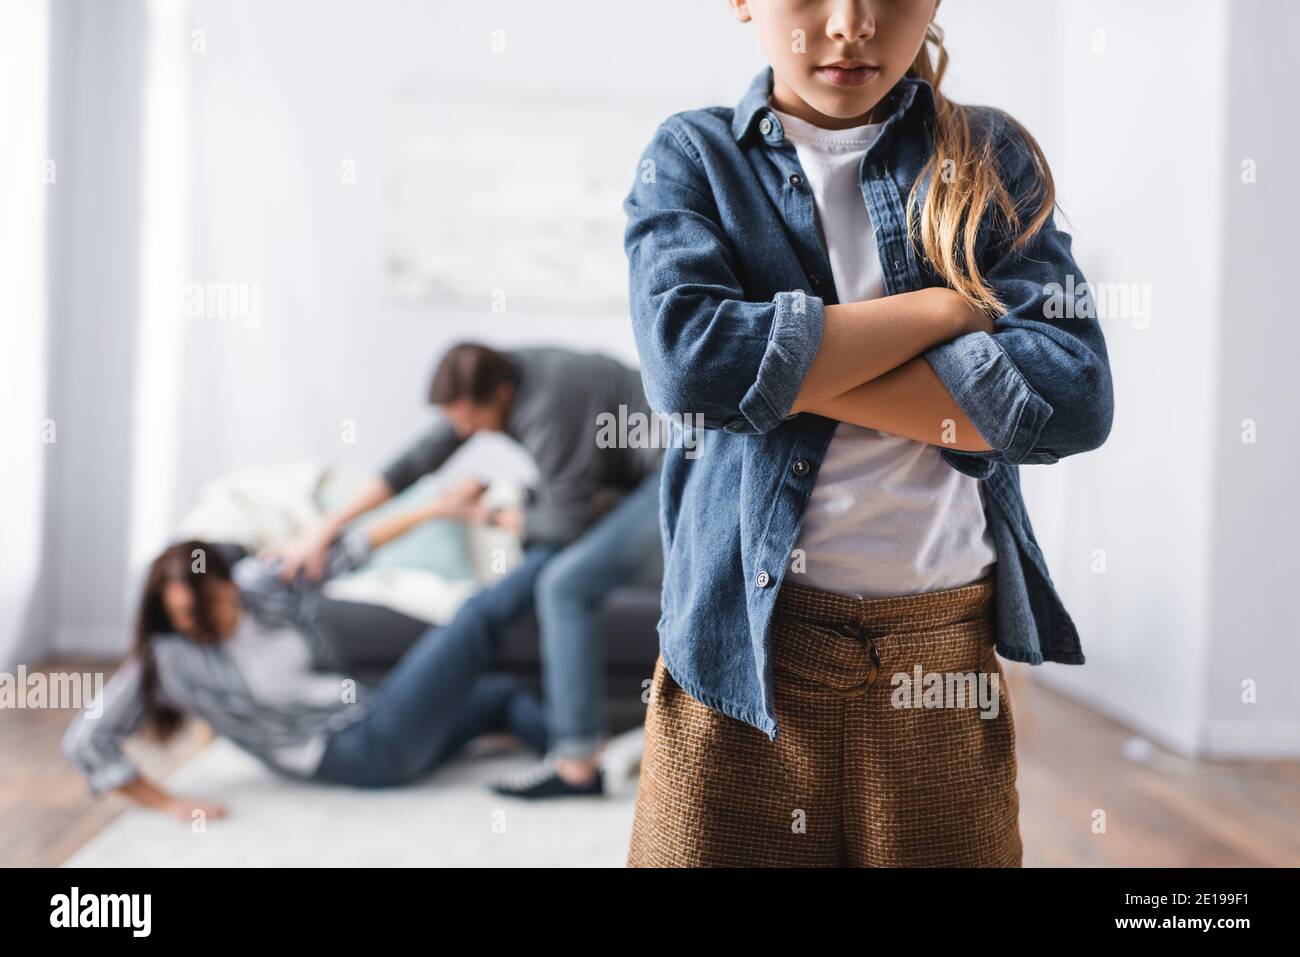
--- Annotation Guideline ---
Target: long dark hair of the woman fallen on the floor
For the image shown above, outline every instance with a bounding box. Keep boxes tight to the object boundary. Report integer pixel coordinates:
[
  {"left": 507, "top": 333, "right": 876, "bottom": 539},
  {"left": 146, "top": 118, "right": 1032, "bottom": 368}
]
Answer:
[{"left": 134, "top": 540, "right": 230, "bottom": 741}]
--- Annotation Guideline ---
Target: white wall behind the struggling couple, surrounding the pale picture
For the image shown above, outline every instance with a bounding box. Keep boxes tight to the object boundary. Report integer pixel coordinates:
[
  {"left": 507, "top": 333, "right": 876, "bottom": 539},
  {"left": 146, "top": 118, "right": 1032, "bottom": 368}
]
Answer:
[{"left": 167, "top": 0, "right": 762, "bottom": 501}]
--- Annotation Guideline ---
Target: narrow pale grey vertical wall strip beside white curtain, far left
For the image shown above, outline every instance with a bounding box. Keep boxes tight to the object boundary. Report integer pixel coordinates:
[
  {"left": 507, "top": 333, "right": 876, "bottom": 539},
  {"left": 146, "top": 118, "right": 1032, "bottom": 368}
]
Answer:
[{"left": 48, "top": 0, "right": 146, "bottom": 653}]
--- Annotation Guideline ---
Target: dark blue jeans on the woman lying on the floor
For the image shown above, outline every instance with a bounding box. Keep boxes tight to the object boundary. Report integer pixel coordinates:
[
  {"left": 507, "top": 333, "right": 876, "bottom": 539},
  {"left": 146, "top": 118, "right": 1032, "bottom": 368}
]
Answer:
[{"left": 316, "top": 546, "right": 555, "bottom": 788}]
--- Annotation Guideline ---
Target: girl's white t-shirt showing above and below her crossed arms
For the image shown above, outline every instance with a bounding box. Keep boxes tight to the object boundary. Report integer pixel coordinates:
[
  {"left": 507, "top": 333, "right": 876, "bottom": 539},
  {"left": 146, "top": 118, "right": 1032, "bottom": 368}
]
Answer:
[{"left": 772, "top": 109, "right": 997, "bottom": 598}]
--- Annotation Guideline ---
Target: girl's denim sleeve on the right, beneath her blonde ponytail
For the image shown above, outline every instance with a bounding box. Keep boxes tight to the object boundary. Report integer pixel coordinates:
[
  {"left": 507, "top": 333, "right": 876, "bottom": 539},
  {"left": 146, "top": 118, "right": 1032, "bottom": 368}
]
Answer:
[{"left": 926, "top": 114, "right": 1114, "bottom": 476}]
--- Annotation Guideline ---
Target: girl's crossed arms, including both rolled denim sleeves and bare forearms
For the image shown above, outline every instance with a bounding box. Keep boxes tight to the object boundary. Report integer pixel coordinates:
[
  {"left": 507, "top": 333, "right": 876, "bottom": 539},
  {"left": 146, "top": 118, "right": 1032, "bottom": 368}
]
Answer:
[{"left": 624, "top": 112, "right": 1114, "bottom": 462}]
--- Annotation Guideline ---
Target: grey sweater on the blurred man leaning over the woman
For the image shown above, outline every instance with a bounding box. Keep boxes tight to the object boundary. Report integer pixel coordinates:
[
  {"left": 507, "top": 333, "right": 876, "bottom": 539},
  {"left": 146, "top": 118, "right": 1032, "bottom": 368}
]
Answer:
[{"left": 384, "top": 348, "right": 663, "bottom": 545}]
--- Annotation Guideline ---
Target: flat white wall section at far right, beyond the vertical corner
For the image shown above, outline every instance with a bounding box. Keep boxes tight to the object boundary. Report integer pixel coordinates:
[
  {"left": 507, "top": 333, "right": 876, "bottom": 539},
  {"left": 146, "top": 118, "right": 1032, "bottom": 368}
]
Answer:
[{"left": 1201, "top": 0, "right": 1300, "bottom": 757}]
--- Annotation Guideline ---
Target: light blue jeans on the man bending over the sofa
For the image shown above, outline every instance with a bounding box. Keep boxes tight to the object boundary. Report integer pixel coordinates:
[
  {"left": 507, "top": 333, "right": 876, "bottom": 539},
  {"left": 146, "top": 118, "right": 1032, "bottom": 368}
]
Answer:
[{"left": 537, "top": 472, "right": 663, "bottom": 759}]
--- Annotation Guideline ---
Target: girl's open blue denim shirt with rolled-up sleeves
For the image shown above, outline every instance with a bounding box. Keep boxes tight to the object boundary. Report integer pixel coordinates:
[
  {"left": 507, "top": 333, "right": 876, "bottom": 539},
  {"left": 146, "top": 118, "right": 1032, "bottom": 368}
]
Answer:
[{"left": 624, "top": 68, "right": 1113, "bottom": 740}]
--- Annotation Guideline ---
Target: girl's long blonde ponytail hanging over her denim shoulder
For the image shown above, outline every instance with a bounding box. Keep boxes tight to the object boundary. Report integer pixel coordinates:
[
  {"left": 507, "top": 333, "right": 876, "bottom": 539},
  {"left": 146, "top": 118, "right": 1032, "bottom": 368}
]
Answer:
[{"left": 907, "top": 22, "right": 1056, "bottom": 313}]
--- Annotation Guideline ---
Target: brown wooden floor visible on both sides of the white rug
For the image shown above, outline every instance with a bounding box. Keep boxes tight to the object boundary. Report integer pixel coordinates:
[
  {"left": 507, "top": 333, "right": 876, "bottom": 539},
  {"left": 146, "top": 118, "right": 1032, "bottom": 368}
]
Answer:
[{"left": 0, "top": 662, "right": 1300, "bottom": 867}]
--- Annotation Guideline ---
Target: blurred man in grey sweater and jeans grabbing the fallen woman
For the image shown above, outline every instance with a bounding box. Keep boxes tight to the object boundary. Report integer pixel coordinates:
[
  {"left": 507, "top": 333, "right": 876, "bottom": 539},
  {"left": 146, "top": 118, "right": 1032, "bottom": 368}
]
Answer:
[{"left": 271, "top": 343, "right": 663, "bottom": 798}]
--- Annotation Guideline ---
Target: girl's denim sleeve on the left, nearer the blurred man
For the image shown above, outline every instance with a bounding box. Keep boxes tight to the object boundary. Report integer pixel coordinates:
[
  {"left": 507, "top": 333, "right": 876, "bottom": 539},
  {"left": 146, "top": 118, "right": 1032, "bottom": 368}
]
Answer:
[{"left": 623, "top": 120, "right": 824, "bottom": 433}]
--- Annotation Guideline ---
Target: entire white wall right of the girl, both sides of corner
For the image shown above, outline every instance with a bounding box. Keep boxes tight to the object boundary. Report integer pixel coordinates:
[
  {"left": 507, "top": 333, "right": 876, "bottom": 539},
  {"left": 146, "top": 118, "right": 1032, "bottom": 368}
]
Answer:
[{"left": 944, "top": 0, "right": 1300, "bottom": 757}]
